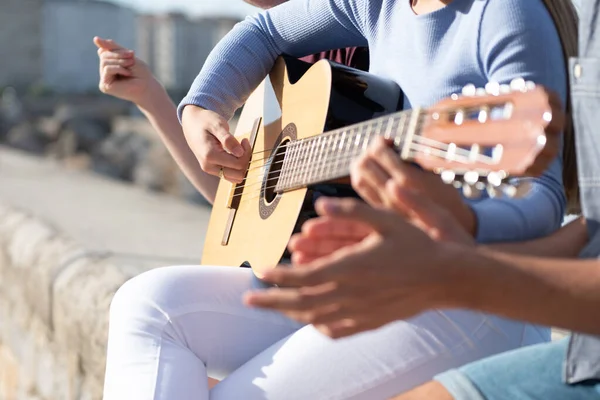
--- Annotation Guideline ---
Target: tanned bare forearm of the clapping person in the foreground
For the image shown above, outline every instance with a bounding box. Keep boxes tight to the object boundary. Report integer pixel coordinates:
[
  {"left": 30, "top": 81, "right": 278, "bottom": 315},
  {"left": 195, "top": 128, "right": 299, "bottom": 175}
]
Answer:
[{"left": 446, "top": 249, "right": 600, "bottom": 334}]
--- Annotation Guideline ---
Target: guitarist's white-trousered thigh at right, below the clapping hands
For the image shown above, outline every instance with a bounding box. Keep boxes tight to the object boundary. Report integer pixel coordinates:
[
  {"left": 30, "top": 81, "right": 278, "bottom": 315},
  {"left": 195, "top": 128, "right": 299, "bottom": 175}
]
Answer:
[{"left": 211, "top": 311, "right": 542, "bottom": 400}]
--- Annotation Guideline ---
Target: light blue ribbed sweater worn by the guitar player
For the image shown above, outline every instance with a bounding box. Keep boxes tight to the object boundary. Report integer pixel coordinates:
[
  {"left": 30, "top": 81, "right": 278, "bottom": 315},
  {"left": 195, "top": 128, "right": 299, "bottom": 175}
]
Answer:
[{"left": 179, "top": 0, "right": 566, "bottom": 242}]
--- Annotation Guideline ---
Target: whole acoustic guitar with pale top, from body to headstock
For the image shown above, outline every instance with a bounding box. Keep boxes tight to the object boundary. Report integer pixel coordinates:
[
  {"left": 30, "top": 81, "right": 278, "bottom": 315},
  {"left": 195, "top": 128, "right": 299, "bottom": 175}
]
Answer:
[{"left": 202, "top": 58, "right": 564, "bottom": 277}]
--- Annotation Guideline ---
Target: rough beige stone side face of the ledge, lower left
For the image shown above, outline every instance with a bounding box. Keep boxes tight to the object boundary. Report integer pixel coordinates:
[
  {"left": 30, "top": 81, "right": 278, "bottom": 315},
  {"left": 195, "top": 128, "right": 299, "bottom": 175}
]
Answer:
[{"left": 0, "top": 205, "right": 160, "bottom": 400}]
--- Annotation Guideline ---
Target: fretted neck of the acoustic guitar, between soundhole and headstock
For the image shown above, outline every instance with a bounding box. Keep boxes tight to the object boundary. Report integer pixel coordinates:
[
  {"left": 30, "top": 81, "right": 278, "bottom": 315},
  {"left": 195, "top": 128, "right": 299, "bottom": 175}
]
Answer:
[{"left": 275, "top": 109, "right": 422, "bottom": 192}]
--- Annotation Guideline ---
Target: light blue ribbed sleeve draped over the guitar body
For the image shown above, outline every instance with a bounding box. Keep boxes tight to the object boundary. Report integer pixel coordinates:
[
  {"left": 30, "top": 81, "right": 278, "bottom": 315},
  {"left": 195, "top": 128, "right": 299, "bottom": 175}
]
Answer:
[{"left": 178, "top": 0, "right": 369, "bottom": 120}]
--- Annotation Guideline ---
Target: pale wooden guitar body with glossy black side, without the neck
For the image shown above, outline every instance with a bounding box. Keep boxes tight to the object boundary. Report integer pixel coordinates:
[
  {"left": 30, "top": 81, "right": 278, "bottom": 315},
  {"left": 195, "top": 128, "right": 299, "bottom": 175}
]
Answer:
[{"left": 202, "top": 58, "right": 403, "bottom": 277}]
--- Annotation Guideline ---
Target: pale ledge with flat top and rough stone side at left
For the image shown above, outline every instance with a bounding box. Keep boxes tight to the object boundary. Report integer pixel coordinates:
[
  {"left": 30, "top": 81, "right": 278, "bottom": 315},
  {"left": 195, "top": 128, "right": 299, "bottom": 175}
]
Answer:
[{"left": 0, "top": 148, "right": 209, "bottom": 400}]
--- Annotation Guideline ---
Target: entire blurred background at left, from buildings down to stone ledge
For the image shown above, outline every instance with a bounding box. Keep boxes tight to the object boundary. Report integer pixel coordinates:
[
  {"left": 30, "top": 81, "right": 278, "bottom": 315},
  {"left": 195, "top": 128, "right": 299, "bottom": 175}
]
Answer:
[{"left": 0, "top": 0, "right": 256, "bottom": 400}]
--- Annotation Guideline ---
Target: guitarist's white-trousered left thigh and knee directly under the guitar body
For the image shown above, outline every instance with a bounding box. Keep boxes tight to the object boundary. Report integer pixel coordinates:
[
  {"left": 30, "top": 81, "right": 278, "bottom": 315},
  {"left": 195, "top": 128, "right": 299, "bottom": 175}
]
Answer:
[{"left": 111, "top": 266, "right": 302, "bottom": 378}]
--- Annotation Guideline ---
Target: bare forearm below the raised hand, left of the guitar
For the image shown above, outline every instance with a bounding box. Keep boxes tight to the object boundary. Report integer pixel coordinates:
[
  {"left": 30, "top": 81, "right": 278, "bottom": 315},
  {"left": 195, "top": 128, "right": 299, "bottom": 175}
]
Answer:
[{"left": 139, "top": 85, "right": 219, "bottom": 204}]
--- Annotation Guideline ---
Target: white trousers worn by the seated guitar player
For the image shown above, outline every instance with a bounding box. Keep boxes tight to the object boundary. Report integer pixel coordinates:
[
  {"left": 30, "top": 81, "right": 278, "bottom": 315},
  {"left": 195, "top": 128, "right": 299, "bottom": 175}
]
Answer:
[{"left": 104, "top": 266, "right": 550, "bottom": 400}]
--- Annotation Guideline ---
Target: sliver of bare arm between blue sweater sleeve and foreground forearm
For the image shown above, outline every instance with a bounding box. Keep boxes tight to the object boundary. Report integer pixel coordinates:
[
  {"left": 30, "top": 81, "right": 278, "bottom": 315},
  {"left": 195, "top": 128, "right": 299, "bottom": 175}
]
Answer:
[{"left": 486, "top": 218, "right": 589, "bottom": 258}]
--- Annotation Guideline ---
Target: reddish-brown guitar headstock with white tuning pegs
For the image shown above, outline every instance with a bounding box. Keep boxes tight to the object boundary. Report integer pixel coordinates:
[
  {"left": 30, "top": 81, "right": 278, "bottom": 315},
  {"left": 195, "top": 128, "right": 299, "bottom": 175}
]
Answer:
[{"left": 411, "top": 79, "right": 565, "bottom": 197}]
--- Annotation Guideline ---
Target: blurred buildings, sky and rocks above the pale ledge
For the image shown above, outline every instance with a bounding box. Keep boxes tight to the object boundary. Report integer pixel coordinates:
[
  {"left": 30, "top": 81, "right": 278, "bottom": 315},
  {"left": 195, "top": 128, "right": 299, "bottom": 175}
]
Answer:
[{"left": 0, "top": 0, "right": 256, "bottom": 203}]
